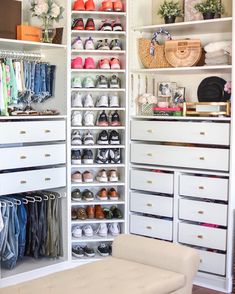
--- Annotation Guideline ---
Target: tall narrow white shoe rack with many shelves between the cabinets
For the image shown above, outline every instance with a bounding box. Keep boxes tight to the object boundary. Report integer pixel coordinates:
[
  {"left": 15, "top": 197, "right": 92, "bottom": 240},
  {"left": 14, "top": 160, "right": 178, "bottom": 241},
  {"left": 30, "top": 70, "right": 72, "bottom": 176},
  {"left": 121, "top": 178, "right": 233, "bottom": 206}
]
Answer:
[{"left": 68, "top": 0, "right": 127, "bottom": 263}]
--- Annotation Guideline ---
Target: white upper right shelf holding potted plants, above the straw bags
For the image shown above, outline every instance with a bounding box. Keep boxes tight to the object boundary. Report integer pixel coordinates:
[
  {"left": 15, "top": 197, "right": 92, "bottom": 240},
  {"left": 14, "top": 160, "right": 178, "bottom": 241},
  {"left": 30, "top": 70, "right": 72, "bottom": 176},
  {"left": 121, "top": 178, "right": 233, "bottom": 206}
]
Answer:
[{"left": 132, "top": 17, "right": 232, "bottom": 36}]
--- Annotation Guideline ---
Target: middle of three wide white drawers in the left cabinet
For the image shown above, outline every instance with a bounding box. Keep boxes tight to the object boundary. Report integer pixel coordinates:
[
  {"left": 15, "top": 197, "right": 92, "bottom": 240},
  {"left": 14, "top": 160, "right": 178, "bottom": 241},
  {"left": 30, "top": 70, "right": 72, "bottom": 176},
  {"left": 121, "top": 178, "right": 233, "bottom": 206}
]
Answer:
[{"left": 0, "top": 144, "right": 66, "bottom": 169}]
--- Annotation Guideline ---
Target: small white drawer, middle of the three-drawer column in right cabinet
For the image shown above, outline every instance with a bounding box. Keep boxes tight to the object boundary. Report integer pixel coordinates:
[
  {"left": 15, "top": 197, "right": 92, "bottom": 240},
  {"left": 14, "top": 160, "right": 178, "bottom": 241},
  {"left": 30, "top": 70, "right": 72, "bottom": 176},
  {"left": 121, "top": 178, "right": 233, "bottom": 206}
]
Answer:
[{"left": 130, "top": 192, "right": 173, "bottom": 217}]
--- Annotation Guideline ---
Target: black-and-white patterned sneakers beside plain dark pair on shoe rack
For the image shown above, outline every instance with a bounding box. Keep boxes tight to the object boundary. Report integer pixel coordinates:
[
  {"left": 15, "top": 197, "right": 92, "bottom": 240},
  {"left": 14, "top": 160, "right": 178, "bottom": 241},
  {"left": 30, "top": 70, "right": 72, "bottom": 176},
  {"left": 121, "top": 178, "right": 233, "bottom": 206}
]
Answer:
[{"left": 95, "top": 148, "right": 121, "bottom": 164}]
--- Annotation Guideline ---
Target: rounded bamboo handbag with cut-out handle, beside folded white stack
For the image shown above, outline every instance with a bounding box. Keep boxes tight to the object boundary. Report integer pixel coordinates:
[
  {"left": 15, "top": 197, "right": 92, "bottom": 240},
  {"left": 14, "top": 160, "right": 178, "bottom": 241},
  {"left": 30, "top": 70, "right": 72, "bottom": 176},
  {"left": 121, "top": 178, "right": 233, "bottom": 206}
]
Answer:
[{"left": 165, "top": 40, "right": 202, "bottom": 67}]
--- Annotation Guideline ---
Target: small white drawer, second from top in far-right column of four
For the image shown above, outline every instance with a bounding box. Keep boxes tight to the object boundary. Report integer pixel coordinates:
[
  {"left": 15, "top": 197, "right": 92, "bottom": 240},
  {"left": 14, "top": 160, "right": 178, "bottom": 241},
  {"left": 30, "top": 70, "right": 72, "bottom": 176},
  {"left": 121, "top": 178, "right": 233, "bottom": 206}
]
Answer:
[{"left": 179, "top": 199, "right": 228, "bottom": 226}]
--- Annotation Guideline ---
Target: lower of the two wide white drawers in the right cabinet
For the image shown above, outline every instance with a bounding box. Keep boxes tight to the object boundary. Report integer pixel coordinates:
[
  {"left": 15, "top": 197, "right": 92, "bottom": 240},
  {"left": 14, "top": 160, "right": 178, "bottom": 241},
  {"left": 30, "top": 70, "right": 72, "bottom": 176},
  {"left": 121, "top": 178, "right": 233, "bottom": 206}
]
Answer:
[{"left": 131, "top": 144, "right": 229, "bottom": 171}]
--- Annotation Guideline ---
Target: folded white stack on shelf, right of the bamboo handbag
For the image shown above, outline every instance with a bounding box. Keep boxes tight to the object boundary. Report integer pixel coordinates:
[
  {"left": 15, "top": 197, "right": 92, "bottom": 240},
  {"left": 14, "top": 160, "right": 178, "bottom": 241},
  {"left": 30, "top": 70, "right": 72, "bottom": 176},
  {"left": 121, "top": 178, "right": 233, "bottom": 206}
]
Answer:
[{"left": 204, "top": 41, "right": 232, "bottom": 65}]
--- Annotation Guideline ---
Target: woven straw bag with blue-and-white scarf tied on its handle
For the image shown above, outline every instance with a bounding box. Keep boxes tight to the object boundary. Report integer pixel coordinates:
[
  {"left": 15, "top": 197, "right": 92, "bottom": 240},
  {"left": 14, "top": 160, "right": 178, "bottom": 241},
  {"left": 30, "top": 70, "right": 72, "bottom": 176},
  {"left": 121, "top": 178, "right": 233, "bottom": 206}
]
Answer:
[{"left": 138, "top": 29, "right": 171, "bottom": 68}]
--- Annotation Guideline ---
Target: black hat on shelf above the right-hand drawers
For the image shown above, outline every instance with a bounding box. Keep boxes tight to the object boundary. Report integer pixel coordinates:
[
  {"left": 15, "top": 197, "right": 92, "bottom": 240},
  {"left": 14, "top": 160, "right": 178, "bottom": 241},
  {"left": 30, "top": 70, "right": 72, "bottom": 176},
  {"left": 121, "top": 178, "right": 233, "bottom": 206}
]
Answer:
[{"left": 197, "top": 77, "right": 231, "bottom": 102}]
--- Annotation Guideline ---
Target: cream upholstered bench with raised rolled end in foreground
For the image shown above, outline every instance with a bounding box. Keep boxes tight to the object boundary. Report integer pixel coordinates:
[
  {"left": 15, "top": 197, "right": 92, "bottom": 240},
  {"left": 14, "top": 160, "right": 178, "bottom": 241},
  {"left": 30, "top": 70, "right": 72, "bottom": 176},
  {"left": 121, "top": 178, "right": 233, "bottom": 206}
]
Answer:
[{"left": 0, "top": 235, "right": 199, "bottom": 294}]
